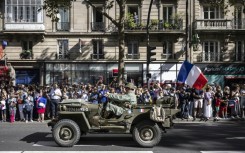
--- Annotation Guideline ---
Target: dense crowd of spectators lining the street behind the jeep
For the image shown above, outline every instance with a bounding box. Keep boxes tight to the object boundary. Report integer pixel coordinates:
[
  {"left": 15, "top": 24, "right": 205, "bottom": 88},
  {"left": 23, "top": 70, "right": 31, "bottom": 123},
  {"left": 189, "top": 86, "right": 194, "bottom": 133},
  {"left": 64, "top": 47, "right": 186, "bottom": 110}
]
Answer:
[{"left": 0, "top": 80, "right": 245, "bottom": 122}]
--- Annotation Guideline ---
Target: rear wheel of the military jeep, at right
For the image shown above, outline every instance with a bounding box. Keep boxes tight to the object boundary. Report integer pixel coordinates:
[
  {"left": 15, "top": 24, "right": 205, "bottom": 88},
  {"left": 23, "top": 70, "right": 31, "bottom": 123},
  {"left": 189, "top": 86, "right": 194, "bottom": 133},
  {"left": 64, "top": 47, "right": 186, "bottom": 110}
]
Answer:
[{"left": 133, "top": 121, "right": 162, "bottom": 147}]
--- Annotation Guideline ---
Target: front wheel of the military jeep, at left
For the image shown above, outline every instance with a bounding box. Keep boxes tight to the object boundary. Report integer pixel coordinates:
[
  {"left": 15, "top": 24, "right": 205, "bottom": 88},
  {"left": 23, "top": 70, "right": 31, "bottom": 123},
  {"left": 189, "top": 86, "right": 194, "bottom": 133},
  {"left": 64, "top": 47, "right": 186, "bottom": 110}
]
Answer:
[{"left": 53, "top": 119, "right": 81, "bottom": 147}]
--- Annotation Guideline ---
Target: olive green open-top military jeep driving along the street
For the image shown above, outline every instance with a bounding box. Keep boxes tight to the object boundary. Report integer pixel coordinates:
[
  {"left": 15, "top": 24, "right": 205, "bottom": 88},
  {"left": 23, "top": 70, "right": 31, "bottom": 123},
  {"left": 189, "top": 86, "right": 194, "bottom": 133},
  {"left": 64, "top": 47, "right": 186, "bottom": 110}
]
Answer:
[{"left": 48, "top": 96, "right": 178, "bottom": 147}]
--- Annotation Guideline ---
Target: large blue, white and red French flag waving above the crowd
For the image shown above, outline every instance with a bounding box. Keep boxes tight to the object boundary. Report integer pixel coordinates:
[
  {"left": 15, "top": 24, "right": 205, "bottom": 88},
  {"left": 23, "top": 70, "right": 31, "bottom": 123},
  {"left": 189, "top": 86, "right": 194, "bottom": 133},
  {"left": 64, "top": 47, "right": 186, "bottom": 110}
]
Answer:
[{"left": 177, "top": 61, "right": 208, "bottom": 89}]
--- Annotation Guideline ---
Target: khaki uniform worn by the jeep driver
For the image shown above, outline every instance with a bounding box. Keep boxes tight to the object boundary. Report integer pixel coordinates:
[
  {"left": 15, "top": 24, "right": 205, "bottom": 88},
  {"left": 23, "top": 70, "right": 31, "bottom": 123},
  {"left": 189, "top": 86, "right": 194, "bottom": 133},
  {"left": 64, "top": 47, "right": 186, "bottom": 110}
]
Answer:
[{"left": 106, "top": 90, "right": 137, "bottom": 116}]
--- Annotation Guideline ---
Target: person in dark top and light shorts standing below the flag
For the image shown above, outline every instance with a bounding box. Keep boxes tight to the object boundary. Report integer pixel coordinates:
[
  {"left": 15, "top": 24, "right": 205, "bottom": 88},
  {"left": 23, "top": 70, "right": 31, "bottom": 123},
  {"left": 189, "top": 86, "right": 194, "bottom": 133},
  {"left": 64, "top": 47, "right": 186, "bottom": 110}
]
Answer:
[{"left": 192, "top": 88, "right": 204, "bottom": 121}]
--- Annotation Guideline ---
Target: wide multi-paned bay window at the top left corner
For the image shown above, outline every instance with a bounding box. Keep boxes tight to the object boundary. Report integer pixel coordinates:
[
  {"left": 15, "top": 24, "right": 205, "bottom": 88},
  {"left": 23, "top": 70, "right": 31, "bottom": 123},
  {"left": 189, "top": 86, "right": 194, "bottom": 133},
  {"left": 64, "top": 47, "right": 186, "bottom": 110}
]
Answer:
[{"left": 5, "top": 0, "right": 43, "bottom": 23}]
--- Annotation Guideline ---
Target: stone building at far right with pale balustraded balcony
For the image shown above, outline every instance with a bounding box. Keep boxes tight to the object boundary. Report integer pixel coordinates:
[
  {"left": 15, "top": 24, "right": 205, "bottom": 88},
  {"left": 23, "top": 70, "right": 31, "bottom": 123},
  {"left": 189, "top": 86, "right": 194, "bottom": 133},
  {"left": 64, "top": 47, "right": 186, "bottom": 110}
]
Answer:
[{"left": 191, "top": 0, "right": 245, "bottom": 86}]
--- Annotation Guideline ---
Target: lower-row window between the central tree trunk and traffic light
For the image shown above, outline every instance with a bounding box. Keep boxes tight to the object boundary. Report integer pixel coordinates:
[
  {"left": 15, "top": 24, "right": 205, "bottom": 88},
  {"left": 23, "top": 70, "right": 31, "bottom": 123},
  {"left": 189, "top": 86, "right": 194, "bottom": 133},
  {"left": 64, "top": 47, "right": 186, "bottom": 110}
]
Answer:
[{"left": 127, "top": 41, "right": 139, "bottom": 59}]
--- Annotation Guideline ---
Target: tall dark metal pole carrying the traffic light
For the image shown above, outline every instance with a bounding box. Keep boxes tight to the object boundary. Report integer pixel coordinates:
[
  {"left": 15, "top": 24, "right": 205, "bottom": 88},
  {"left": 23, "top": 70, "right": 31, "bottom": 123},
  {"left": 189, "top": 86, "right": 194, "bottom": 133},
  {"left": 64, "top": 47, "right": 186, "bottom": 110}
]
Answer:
[{"left": 146, "top": 0, "right": 153, "bottom": 89}]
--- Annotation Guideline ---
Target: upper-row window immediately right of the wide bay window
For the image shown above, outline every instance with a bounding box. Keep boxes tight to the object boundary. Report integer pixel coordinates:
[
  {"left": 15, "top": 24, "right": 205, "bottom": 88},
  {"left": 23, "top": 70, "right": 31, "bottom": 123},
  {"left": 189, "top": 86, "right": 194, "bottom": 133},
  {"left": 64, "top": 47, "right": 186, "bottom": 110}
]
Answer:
[{"left": 57, "top": 8, "right": 70, "bottom": 31}]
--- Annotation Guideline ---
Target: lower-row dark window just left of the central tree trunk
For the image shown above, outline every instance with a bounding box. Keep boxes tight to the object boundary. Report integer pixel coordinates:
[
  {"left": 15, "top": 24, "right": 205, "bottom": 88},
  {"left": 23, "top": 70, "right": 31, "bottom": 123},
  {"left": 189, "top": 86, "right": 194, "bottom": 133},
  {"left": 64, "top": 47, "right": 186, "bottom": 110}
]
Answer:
[{"left": 92, "top": 39, "right": 104, "bottom": 59}]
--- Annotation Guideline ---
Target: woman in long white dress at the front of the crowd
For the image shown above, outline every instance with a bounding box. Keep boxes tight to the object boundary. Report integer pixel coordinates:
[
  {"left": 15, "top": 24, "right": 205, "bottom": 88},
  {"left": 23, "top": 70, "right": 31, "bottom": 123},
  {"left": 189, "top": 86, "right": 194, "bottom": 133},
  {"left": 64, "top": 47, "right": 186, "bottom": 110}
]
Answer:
[{"left": 203, "top": 86, "right": 213, "bottom": 121}]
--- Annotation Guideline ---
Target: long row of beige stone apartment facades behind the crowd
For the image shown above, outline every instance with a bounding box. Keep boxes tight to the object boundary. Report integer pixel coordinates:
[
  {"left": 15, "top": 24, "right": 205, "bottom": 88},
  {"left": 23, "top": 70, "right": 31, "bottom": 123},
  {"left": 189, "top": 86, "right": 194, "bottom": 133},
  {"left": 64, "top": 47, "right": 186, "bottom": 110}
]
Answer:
[{"left": 0, "top": 0, "right": 245, "bottom": 85}]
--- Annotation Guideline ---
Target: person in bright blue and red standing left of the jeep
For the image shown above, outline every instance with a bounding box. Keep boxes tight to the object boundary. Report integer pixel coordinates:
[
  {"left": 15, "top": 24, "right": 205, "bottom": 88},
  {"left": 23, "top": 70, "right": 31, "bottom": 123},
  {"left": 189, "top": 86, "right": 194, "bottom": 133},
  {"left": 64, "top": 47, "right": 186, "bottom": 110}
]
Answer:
[{"left": 36, "top": 91, "right": 47, "bottom": 122}]
